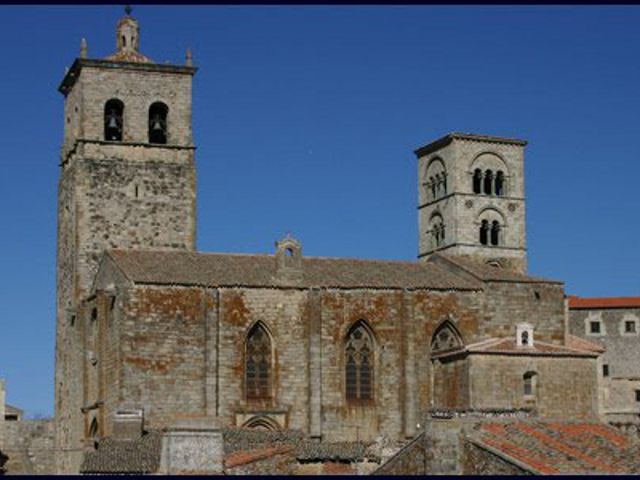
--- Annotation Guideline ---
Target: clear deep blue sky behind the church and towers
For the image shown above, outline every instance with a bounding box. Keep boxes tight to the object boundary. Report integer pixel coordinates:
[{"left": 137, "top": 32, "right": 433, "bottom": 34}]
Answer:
[{"left": 0, "top": 6, "right": 640, "bottom": 415}]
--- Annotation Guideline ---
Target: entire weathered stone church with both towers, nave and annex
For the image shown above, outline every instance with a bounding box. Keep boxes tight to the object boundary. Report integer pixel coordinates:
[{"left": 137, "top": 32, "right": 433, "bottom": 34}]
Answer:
[{"left": 55, "top": 9, "right": 600, "bottom": 472}]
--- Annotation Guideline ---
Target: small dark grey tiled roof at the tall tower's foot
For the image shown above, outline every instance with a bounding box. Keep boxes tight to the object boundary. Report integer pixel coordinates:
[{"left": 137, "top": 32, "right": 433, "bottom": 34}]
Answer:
[{"left": 80, "top": 432, "right": 162, "bottom": 473}]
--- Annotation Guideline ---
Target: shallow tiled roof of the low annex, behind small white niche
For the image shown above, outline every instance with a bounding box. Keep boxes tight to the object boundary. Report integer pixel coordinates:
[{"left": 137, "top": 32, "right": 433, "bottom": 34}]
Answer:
[{"left": 433, "top": 338, "right": 600, "bottom": 357}]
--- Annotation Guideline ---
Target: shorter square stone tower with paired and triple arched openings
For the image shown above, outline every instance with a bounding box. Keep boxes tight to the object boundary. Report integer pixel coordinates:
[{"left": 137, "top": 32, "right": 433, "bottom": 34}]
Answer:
[{"left": 415, "top": 133, "right": 527, "bottom": 273}]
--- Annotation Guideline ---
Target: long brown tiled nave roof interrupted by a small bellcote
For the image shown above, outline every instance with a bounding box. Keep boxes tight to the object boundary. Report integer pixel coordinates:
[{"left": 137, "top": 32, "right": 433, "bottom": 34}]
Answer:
[{"left": 108, "top": 250, "right": 481, "bottom": 290}]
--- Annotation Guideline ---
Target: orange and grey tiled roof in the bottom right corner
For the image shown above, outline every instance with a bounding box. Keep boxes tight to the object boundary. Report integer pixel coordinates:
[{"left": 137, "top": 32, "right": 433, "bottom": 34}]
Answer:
[{"left": 469, "top": 420, "right": 640, "bottom": 474}]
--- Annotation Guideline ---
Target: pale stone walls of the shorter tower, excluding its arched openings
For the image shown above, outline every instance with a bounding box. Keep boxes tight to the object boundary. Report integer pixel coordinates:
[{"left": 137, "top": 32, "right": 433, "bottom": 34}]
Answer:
[{"left": 418, "top": 139, "right": 527, "bottom": 272}]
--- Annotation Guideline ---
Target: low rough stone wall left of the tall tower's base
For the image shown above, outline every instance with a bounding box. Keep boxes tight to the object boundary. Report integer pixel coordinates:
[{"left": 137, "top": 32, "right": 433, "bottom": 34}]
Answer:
[{"left": 3, "top": 419, "right": 56, "bottom": 475}]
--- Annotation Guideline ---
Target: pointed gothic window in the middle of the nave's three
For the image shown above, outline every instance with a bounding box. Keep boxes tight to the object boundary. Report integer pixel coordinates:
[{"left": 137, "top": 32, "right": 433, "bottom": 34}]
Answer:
[{"left": 345, "top": 322, "right": 374, "bottom": 401}]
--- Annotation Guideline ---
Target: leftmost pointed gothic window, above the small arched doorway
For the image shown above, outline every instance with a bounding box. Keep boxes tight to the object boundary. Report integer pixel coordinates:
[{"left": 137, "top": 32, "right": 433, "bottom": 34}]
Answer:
[{"left": 245, "top": 323, "right": 271, "bottom": 399}]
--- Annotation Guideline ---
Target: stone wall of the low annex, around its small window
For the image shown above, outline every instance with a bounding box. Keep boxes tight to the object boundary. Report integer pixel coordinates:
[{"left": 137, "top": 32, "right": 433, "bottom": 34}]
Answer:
[{"left": 469, "top": 354, "right": 597, "bottom": 418}]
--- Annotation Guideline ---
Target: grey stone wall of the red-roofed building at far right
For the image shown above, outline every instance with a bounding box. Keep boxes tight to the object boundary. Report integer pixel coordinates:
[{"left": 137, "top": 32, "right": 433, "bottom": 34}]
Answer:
[{"left": 569, "top": 308, "right": 640, "bottom": 421}]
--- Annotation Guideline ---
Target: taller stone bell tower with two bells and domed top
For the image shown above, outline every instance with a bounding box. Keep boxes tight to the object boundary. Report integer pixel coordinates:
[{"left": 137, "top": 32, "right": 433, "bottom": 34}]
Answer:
[{"left": 55, "top": 10, "right": 196, "bottom": 472}]
